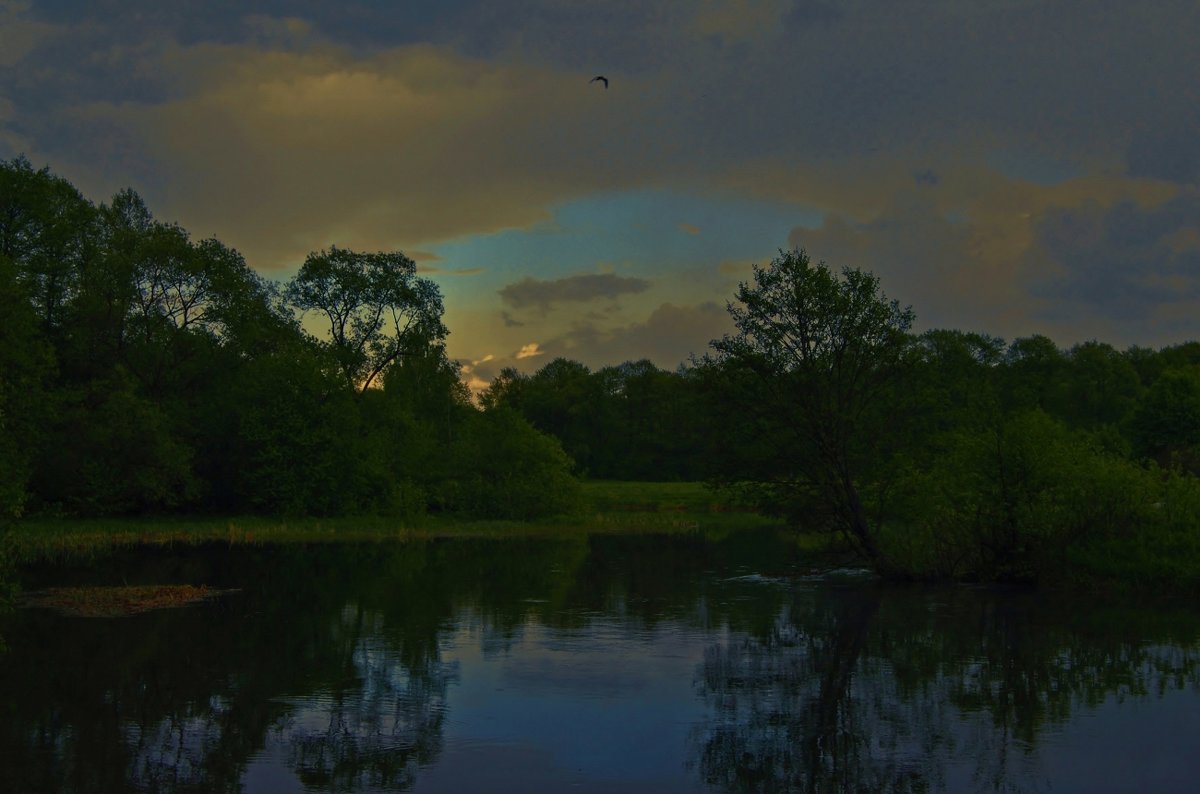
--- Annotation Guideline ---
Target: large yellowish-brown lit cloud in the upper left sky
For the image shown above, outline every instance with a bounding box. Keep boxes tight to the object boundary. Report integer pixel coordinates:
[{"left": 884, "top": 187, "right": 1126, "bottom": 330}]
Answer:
[{"left": 73, "top": 43, "right": 686, "bottom": 269}]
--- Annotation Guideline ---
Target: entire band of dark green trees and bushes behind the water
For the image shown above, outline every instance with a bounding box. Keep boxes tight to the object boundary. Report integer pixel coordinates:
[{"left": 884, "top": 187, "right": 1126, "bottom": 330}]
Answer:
[{"left": 0, "top": 158, "right": 1200, "bottom": 588}]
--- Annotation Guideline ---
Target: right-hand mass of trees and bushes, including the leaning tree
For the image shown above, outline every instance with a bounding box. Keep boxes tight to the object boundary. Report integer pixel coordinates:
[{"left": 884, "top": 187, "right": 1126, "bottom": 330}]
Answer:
[{"left": 485, "top": 251, "right": 1200, "bottom": 587}]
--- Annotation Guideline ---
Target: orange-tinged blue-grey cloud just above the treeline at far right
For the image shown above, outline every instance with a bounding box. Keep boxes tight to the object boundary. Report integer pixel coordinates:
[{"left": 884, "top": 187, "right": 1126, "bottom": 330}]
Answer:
[{"left": 788, "top": 169, "right": 1200, "bottom": 344}]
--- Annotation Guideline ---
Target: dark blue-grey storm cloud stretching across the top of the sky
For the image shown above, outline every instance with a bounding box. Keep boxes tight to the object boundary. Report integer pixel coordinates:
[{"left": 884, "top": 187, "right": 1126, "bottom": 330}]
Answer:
[{"left": 8, "top": 0, "right": 1200, "bottom": 178}]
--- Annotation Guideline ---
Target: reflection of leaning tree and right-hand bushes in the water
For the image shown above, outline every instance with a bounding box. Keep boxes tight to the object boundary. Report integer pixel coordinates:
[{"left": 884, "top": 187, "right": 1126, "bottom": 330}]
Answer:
[{"left": 689, "top": 587, "right": 1200, "bottom": 792}]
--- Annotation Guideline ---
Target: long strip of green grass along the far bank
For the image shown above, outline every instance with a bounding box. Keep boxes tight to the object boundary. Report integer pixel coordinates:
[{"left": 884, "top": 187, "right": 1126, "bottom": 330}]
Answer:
[{"left": 0, "top": 481, "right": 774, "bottom": 565}]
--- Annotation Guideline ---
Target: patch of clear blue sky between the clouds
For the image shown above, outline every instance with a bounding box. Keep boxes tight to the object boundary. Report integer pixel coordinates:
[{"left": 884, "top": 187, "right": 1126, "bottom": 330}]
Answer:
[{"left": 431, "top": 190, "right": 823, "bottom": 291}]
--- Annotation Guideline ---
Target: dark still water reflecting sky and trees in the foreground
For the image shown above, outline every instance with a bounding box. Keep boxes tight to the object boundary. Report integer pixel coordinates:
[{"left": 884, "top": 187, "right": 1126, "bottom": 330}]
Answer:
[{"left": 0, "top": 534, "right": 1200, "bottom": 794}]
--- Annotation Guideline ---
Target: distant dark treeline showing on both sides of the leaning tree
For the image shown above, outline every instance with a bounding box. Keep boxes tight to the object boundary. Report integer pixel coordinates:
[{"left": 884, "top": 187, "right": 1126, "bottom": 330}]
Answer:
[{"left": 480, "top": 329, "right": 1200, "bottom": 482}]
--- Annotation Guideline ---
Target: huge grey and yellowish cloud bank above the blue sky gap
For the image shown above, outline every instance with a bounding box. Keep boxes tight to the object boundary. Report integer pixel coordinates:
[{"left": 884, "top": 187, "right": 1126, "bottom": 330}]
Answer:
[{"left": 21, "top": 0, "right": 1200, "bottom": 273}]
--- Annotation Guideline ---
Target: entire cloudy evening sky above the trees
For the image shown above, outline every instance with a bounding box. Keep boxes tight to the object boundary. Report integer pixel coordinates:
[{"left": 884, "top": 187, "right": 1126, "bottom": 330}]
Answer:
[{"left": 0, "top": 0, "right": 1200, "bottom": 387}]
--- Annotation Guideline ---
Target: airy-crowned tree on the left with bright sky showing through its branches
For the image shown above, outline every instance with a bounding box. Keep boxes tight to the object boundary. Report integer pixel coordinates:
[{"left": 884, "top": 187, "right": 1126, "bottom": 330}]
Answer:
[{"left": 288, "top": 247, "right": 446, "bottom": 392}]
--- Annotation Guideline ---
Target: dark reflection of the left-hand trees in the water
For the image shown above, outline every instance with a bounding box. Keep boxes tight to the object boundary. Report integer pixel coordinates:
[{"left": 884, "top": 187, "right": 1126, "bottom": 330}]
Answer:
[{"left": 0, "top": 546, "right": 487, "bottom": 793}]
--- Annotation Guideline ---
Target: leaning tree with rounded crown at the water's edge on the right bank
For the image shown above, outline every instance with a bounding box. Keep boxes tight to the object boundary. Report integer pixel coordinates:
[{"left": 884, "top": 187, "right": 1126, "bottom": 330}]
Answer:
[{"left": 704, "top": 249, "right": 913, "bottom": 566}]
